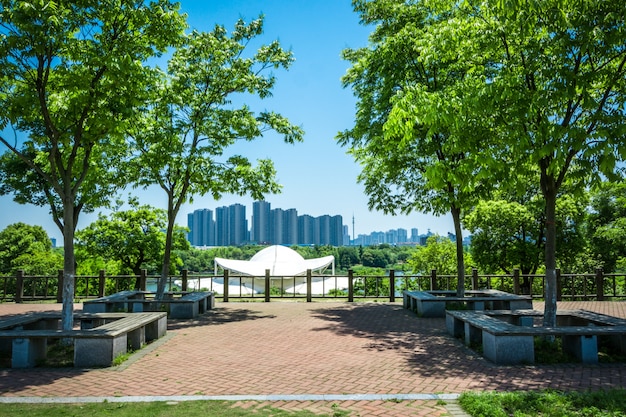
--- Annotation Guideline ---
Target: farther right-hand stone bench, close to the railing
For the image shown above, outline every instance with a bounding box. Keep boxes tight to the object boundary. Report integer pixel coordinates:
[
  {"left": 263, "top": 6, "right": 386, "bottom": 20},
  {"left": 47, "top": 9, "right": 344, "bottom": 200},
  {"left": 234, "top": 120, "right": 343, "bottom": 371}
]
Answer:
[{"left": 402, "top": 290, "right": 532, "bottom": 317}]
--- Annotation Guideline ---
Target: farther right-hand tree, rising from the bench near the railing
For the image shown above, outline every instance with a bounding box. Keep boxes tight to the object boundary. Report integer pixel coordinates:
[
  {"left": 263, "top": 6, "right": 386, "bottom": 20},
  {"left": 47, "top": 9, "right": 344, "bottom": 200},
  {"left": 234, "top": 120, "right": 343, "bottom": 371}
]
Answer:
[{"left": 338, "top": 0, "right": 489, "bottom": 296}]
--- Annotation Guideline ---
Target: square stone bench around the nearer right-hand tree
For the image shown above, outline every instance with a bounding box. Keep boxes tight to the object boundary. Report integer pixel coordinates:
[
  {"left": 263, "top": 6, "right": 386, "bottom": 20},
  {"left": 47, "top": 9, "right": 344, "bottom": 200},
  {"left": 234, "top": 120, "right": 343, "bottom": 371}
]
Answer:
[{"left": 446, "top": 310, "right": 626, "bottom": 364}]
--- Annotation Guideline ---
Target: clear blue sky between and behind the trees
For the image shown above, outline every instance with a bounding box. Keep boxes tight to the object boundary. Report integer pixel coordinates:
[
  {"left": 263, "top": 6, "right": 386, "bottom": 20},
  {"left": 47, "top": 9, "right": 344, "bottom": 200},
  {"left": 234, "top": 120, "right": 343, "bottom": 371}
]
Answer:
[{"left": 0, "top": 0, "right": 454, "bottom": 242}]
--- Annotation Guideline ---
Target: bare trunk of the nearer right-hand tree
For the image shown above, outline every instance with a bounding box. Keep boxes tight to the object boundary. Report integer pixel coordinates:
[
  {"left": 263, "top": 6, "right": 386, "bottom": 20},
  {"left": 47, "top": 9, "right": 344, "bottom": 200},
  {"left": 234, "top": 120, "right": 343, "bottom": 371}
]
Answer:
[{"left": 541, "top": 173, "right": 557, "bottom": 327}]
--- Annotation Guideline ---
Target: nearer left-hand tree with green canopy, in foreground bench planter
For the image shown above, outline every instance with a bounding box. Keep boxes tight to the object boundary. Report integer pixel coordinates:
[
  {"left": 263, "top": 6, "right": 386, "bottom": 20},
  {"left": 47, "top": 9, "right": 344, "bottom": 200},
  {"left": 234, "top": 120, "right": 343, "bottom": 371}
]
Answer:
[{"left": 0, "top": 0, "right": 184, "bottom": 329}]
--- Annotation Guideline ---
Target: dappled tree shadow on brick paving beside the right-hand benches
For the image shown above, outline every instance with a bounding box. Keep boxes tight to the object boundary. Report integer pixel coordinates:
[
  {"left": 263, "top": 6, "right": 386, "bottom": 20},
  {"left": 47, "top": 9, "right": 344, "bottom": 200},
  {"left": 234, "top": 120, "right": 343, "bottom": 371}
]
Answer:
[{"left": 312, "top": 303, "right": 626, "bottom": 390}]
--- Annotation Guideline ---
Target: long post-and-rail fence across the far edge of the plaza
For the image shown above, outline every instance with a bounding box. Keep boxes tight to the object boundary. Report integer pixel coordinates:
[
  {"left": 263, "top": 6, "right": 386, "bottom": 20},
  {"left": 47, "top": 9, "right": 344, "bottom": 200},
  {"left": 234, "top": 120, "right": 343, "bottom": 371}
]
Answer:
[{"left": 0, "top": 269, "right": 626, "bottom": 302}]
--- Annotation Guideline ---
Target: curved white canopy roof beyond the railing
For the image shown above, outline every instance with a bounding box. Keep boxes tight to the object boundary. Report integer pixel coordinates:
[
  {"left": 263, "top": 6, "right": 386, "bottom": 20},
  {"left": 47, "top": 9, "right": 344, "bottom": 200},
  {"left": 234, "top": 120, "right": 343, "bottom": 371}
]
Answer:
[{"left": 215, "top": 245, "right": 335, "bottom": 277}]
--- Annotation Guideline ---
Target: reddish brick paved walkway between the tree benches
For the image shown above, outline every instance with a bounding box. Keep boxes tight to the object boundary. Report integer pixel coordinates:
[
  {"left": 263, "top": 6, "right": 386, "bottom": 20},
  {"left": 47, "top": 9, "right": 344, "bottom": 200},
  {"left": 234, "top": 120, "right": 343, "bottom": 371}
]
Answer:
[{"left": 0, "top": 302, "right": 626, "bottom": 417}]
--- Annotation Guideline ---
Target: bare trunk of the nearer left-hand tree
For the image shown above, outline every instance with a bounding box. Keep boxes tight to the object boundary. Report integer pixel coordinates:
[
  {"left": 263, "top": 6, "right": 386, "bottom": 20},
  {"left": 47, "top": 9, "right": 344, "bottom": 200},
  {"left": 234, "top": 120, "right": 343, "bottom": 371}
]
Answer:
[{"left": 61, "top": 199, "right": 76, "bottom": 330}]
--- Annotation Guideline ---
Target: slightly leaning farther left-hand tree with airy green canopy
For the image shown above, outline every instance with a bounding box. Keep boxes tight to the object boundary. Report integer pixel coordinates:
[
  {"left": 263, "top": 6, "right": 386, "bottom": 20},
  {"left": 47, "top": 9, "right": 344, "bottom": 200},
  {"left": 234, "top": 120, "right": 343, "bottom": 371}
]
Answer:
[{"left": 131, "top": 18, "right": 302, "bottom": 298}]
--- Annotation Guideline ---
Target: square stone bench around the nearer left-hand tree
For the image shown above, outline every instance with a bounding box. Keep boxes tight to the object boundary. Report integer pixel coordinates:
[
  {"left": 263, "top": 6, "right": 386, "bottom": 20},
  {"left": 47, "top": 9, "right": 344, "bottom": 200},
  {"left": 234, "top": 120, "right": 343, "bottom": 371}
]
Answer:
[{"left": 0, "top": 312, "right": 167, "bottom": 368}]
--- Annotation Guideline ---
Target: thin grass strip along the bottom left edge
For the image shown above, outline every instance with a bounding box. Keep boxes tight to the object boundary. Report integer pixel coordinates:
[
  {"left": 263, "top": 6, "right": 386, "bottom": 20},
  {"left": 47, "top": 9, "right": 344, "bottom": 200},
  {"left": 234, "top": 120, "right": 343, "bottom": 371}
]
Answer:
[{"left": 0, "top": 401, "right": 342, "bottom": 417}]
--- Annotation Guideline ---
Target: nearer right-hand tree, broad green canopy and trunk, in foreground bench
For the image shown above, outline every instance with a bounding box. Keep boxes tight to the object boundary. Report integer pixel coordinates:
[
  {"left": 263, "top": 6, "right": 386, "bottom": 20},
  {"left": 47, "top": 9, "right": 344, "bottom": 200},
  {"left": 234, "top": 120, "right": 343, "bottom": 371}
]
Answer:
[{"left": 344, "top": 0, "right": 626, "bottom": 325}]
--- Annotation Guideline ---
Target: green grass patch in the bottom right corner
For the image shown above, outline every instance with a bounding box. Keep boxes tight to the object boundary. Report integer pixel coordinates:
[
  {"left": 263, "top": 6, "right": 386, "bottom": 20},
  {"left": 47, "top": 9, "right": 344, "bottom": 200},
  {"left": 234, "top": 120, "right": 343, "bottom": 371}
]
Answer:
[{"left": 459, "top": 389, "right": 626, "bottom": 417}]
